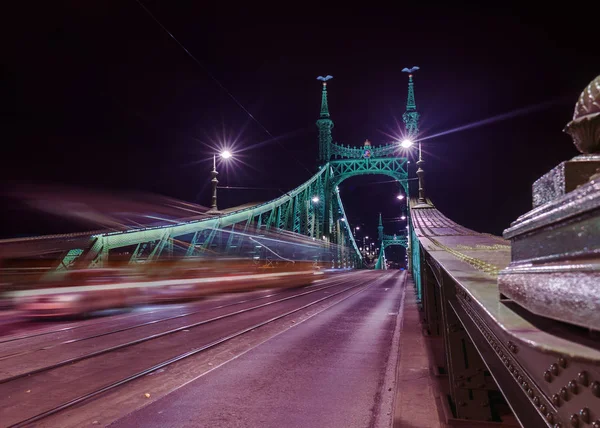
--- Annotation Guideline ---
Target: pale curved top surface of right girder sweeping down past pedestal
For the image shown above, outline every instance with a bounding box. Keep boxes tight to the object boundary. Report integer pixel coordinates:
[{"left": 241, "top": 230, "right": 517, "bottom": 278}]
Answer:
[{"left": 412, "top": 205, "right": 600, "bottom": 362}]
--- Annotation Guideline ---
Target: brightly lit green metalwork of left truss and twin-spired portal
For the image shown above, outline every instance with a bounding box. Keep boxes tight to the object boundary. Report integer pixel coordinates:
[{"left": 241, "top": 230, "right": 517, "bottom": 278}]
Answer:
[{"left": 44, "top": 72, "right": 419, "bottom": 274}]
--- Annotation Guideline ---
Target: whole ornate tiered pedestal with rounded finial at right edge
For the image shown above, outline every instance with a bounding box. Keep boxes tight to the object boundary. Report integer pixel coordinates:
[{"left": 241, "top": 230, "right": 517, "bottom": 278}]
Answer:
[{"left": 498, "top": 76, "right": 600, "bottom": 330}]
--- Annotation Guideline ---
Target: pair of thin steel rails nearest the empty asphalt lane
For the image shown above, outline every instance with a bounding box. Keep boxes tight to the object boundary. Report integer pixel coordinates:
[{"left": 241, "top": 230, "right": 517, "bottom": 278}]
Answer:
[{"left": 4, "top": 277, "right": 378, "bottom": 427}]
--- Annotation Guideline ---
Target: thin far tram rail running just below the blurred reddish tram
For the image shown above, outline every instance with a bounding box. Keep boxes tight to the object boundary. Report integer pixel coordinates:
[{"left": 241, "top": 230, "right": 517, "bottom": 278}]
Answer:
[{"left": 0, "top": 272, "right": 352, "bottom": 360}]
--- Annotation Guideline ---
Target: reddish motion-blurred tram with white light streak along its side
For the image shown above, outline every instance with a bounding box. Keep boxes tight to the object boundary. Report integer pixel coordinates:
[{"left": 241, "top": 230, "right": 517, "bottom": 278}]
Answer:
[{"left": 5, "top": 258, "right": 324, "bottom": 318}]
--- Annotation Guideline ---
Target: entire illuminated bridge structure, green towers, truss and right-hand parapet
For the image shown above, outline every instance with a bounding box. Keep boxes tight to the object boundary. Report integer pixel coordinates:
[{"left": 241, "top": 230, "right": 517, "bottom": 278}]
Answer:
[{"left": 0, "top": 74, "right": 600, "bottom": 427}]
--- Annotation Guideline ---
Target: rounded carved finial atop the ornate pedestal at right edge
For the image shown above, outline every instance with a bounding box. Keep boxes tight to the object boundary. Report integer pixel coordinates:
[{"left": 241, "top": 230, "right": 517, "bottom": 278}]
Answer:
[{"left": 563, "top": 76, "right": 600, "bottom": 154}]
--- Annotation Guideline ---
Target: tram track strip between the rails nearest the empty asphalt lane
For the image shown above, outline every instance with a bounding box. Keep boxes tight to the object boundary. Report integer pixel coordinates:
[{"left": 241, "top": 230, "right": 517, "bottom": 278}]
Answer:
[{"left": 0, "top": 275, "right": 384, "bottom": 427}]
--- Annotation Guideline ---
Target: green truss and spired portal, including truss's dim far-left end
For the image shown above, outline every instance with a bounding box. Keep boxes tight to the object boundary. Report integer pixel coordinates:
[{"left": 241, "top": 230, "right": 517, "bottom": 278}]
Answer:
[{"left": 0, "top": 72, "right": 419, "bottom": 270}]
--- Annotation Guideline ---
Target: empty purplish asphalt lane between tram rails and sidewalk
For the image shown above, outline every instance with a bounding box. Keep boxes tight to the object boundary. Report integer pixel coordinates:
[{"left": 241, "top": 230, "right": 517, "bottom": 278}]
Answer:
[{"left": 110, "top": 271, "right": 406, "bottom": 428}]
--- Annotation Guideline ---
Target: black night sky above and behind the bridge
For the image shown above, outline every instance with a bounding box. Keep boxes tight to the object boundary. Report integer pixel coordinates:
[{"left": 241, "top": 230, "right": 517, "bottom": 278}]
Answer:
[{"left": 0, "top": 0, "right": 600, "bottom": 247}]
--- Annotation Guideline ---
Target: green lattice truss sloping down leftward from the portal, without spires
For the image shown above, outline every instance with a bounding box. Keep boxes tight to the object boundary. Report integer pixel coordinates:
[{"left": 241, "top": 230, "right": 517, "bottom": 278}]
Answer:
[{"left": 49, "top": 165, "right": 376, "bottom": 270}]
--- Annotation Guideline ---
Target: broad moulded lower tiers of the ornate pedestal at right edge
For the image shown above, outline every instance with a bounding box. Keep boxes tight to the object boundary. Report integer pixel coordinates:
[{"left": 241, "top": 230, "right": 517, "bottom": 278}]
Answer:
[{"left": 498, "top": 179, "right": 600, "bottom": 330}]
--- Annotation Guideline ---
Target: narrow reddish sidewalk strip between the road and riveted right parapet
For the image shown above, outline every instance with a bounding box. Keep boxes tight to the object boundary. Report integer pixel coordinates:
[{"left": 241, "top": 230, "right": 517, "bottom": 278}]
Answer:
[{"left": 393, "top": 277, "right": 447, "bottom": 428}]
